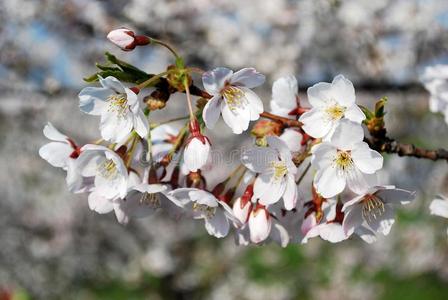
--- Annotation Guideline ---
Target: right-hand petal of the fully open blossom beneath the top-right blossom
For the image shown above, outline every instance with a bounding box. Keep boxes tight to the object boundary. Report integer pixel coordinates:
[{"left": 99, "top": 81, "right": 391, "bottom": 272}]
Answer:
[{"left": 352, "top": 142, "right": 383, "bottom": 174}]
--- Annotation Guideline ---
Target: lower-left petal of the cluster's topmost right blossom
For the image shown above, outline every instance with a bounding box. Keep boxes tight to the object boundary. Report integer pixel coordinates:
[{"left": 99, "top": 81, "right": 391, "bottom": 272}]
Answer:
[{"left": 299, "top": 108, "right": 333, "bottom": 138}]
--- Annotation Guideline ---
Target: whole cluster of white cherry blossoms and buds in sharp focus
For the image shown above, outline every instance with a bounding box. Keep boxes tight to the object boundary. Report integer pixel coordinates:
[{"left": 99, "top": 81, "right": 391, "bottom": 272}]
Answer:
[{"left": 39, "top": 29, "right": 420, "bottom": 246}]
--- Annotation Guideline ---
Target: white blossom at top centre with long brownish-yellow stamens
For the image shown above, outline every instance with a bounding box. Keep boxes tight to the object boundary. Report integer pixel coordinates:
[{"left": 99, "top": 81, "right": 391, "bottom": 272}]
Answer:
[{"left": 202, "top": 67, "right": 265, "bottom": 134}]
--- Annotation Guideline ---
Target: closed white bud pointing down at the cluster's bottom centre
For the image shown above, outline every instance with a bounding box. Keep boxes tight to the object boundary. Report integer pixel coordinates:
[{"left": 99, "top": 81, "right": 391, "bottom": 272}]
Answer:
[{"left": 249, "top": 204, "right": 272, "bottom": 243}]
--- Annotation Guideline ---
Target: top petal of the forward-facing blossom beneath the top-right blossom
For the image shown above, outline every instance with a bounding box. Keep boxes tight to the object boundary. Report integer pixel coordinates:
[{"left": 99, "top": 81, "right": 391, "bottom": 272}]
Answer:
[{"left": 330, "top": 119, "right": 364, "bottom": 150}]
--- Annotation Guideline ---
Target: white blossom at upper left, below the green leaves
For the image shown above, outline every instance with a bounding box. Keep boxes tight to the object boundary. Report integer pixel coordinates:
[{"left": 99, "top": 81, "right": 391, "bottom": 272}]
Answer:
[{"left": 79, "top": 76, "right": 149, "bottom": 143}]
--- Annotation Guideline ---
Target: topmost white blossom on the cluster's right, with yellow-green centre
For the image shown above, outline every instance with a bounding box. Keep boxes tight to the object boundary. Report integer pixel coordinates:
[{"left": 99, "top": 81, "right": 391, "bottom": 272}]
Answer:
[{"left": 299, "top": 75, "right": 365, "bottom": 139}]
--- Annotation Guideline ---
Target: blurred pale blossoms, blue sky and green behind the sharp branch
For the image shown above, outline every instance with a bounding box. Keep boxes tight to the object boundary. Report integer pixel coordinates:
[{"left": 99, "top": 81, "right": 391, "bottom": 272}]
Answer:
[{"left": 0, "top": 0, "right": 448, "bottom": 300}]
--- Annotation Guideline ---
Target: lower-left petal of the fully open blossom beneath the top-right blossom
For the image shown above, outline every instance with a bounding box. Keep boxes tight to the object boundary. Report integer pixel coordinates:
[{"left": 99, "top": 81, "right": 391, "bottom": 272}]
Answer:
[{"left": 314, "top": 167, "right": 346, "bottom": 198}]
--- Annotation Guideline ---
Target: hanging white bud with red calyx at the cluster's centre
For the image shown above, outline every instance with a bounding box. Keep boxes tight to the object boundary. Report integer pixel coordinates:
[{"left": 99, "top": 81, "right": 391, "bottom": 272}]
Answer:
[{"left": 184, "top": 119, "right": 210, "bottom": 172}]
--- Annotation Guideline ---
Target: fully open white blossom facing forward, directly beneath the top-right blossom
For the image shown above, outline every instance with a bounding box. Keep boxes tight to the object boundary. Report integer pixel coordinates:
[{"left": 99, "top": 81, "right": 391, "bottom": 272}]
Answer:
[{"left": 311, "top": 120, "right": 383, "bottom": 198}]
